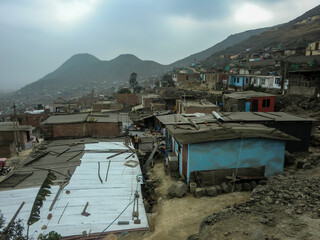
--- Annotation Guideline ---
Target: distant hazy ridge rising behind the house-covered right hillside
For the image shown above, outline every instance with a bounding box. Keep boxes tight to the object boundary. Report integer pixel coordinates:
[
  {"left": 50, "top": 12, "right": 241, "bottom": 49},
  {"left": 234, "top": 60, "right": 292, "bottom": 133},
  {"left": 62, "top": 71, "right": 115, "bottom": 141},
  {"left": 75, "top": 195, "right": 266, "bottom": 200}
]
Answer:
[{"left": 171, "top": 27, "right": 270, "bottom": 67}]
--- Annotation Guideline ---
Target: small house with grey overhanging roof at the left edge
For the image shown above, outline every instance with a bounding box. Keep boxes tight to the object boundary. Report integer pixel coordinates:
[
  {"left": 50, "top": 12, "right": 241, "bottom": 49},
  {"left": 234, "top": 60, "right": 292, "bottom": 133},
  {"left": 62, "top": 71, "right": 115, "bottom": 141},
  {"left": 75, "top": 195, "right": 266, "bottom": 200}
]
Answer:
[{"left": 0, "top": 122, "right": 34, "bottom": 158}]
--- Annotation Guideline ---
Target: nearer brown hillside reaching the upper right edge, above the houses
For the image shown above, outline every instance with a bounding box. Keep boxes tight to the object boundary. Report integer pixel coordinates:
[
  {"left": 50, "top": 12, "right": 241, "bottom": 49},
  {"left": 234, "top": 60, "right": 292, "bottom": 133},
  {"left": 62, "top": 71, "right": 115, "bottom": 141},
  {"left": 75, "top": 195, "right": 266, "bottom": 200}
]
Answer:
[{"left": 205, "top": 5, "right": 320, "bottom": 65}]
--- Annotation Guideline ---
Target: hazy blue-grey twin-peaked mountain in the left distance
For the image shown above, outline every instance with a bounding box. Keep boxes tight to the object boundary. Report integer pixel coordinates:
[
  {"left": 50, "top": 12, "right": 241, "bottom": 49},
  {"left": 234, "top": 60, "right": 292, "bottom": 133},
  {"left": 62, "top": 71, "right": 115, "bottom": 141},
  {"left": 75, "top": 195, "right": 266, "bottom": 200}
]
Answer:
[{"left": 9, "top": 53, "right": 170, "bottom": 105}]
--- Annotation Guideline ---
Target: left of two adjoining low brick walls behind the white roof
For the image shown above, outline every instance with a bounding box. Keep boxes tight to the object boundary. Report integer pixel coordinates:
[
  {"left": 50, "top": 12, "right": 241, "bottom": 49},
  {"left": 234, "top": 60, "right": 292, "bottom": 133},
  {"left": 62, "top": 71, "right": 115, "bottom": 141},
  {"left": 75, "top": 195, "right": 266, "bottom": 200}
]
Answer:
[{"left": 52, "top": 123, "right": 84, "bottom": 137}]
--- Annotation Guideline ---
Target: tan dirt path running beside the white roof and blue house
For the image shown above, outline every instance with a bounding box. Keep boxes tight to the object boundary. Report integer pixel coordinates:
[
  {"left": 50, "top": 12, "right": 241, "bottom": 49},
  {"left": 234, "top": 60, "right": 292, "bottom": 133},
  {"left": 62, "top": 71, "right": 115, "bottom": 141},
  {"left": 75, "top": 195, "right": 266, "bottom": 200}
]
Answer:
[{"left": 124, "top": 162, "right": 250, "bottom": 240}]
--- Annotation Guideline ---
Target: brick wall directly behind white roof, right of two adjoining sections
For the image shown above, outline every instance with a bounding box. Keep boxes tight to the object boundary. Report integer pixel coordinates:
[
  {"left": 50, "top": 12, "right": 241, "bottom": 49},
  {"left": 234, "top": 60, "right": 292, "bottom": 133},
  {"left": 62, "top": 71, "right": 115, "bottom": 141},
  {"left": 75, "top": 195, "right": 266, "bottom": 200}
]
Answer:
[{"left": 87, "top": 123, "right": 120, "bottom": 137}]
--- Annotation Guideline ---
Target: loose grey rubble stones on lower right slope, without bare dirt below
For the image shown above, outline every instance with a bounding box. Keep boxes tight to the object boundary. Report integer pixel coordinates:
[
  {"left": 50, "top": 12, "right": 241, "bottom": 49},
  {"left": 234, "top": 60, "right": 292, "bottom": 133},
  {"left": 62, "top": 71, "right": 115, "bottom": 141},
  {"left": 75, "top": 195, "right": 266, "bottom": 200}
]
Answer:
[{"left": 188, "top": 171, "right": 320, "bottom": 239}]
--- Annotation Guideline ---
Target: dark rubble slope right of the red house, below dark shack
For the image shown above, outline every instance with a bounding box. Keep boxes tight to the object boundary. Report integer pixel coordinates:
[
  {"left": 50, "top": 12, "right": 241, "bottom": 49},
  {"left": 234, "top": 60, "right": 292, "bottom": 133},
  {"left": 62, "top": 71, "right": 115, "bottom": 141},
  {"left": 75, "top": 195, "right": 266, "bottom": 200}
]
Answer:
[{"left": 275, "top": 94, "right": 320, "bottom": 113}]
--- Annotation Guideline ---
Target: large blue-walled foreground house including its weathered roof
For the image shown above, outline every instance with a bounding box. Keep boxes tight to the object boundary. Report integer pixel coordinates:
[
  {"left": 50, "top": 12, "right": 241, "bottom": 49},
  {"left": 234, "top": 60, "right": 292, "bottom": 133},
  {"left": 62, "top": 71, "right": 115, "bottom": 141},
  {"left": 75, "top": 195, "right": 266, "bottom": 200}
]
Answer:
[{"left": 167, "top": 123, "right": 298, "bottom": 184}]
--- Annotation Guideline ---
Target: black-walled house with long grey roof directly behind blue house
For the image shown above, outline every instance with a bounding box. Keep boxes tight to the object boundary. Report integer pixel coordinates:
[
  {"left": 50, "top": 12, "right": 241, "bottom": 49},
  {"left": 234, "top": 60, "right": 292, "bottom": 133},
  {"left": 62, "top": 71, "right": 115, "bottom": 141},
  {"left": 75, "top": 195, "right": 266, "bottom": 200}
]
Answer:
[{"left": 156, "top": 112, "right": 315, "bottom": 152}]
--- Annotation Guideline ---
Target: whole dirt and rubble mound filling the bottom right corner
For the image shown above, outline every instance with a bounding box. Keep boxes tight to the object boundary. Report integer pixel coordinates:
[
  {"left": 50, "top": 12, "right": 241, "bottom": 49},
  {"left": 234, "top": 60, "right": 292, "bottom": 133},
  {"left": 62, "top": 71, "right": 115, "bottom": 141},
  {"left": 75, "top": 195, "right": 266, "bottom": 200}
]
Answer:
[{"left": 188, "top": 168, "right": 320, "bottom": 240}]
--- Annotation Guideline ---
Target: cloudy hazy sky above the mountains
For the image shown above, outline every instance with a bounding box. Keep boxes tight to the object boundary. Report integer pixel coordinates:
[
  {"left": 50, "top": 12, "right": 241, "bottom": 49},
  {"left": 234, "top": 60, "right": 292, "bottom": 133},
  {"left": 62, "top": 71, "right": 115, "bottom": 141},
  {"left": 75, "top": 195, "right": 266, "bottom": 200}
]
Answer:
[{"left": 0, "top": 0, "right": 319, "bottom": 90}]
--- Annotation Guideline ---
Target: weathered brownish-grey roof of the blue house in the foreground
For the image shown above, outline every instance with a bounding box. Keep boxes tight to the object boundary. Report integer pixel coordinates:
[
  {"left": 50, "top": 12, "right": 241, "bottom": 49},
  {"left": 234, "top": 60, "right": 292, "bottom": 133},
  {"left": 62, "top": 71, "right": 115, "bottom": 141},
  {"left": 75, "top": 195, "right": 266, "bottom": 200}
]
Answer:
[{"left": 167, "top": 123, "right": 299, "bottom": 144}]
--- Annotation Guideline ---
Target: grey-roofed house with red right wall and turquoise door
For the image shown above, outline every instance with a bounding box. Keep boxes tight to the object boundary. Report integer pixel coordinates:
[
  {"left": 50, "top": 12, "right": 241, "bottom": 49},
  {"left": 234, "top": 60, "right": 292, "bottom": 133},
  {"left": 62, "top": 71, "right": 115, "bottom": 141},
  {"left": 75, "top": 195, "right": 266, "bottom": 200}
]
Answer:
[{"left": 222, "top": 91, "right": 275, "bottom": 112}]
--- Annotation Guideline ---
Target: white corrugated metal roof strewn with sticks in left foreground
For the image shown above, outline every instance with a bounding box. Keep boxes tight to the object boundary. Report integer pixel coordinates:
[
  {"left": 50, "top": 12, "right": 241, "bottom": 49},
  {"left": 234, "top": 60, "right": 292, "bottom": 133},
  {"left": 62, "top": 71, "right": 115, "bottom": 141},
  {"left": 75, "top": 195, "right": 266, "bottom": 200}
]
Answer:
[{"left": 0, "top": 142, "right": 148, "bottom": 238}]
